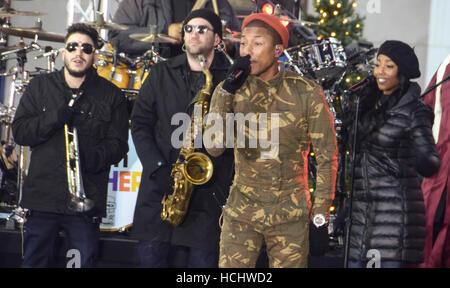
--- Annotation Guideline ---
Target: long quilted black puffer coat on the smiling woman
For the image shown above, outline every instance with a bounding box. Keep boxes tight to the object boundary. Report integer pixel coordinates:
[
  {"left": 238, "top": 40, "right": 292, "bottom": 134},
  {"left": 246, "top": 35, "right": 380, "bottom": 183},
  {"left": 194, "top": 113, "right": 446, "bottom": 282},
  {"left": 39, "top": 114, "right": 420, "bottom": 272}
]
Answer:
[{"left": 350, "top": 83, "right": 440, "bottom": 263}]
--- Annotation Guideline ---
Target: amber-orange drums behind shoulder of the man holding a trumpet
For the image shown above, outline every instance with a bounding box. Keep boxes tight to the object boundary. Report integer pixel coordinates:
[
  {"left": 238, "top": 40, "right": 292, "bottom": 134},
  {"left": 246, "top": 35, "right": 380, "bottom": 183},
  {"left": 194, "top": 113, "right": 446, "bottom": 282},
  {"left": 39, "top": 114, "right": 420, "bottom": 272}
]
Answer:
[{"left": 95, "top": 44, "right": 130, "bottom": 89}]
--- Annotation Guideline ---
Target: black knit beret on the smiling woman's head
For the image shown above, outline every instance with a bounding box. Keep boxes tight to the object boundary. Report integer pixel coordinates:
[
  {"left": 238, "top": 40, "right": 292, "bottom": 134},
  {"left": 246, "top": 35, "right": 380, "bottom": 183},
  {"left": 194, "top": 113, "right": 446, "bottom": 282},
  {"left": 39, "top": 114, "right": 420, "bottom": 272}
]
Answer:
[{"left": 378, "top": 40, "right": 421, "bottom": 79}]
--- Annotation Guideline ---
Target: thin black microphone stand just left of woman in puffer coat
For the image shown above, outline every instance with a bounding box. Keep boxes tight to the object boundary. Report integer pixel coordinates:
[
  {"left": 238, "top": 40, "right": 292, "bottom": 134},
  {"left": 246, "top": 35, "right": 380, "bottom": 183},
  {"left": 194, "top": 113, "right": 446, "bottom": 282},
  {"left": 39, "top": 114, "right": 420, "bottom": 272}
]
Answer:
[{"left": 344, "top": 96, "right": 360, "bottom": 268}]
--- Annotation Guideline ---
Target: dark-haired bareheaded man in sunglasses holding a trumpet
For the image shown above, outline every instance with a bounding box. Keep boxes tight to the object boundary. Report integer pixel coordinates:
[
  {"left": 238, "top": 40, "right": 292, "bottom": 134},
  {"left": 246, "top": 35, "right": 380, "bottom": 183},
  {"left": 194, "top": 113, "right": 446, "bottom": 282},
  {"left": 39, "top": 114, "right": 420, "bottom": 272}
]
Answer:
[{"left": 12, "top": 23, "right": 128, "bottom": 267}]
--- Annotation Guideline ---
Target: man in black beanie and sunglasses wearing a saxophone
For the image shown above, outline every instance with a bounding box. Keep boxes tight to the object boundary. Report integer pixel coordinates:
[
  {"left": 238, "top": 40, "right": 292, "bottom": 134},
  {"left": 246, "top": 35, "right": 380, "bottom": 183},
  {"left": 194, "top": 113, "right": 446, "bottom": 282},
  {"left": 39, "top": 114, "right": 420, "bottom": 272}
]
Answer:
[{"left": 131, "top": 9, "right": 233, "bottom": 267}]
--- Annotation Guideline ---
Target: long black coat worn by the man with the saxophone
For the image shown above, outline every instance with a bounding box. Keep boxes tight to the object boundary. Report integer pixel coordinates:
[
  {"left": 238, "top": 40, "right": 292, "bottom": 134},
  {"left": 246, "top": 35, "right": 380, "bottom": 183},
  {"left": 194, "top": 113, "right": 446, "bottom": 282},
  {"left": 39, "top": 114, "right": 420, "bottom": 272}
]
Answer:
[{"left": 131, "top": 53, "right": 233, "bottom": 250}]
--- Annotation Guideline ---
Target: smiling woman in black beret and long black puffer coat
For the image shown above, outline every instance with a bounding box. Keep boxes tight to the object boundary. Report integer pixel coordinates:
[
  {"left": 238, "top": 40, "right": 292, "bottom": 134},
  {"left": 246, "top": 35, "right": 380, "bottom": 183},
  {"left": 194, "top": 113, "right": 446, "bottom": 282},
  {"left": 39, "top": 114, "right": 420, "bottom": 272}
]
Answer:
[{"left": 348, "top": 41, "right": 440, "bottom": 268}]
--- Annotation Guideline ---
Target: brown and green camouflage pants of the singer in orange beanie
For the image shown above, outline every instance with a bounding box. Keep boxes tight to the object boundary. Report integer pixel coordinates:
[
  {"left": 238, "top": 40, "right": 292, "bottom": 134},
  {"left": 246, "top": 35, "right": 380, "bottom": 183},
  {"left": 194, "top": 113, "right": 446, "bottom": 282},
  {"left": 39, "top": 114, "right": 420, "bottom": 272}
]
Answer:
[{"left": 219, "top": 185, "right": 309, "bottom": 268}]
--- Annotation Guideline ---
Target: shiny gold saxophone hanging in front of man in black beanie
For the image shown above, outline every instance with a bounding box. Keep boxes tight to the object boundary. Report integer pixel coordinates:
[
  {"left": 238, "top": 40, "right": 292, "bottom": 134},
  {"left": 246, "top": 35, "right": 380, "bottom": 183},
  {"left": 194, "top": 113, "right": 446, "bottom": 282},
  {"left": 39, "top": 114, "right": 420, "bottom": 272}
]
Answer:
[{"left": 161, "top": 56, "right": 213, "bottom": 227}]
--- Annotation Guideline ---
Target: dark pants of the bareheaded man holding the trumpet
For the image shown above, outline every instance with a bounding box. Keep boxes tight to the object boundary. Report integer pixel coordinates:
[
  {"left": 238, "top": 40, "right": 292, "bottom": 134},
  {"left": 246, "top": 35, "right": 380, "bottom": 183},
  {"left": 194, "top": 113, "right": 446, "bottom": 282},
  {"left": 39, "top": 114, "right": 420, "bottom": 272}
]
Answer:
[{"left": 22, "top": 211, "right": 100, "bottom": 268}]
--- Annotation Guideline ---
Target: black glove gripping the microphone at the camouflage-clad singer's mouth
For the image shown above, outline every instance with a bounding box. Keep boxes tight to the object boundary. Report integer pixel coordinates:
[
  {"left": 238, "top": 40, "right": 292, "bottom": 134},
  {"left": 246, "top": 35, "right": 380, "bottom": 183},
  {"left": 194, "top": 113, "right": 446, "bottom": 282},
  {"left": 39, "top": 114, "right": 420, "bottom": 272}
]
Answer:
[{"left": 222, "top": 55, "right": 250, "bottom": 94}]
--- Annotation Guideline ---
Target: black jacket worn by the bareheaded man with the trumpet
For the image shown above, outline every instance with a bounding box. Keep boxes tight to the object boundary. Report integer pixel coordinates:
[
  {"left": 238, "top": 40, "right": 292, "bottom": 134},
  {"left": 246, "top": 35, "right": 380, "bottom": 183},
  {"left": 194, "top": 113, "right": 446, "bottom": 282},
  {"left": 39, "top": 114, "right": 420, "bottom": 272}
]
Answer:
[{"left": 12, "top": 69, "right": 128, "bottom": 216}]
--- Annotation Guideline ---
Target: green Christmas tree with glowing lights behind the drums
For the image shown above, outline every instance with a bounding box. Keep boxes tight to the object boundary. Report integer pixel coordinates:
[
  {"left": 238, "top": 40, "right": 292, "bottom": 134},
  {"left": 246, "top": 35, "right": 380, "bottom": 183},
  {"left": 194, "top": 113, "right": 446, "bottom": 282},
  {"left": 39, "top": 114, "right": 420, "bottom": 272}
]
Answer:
[{"left": 305, "top": 0, "right": 364, "bottom": 47}]
